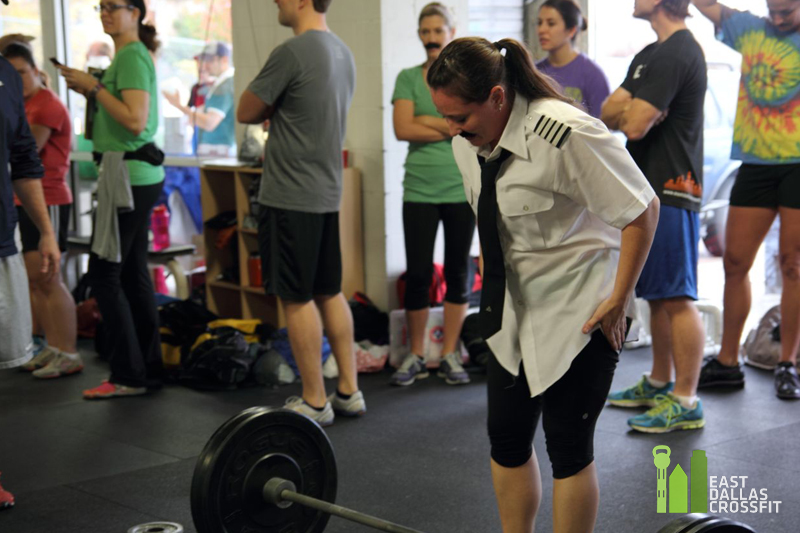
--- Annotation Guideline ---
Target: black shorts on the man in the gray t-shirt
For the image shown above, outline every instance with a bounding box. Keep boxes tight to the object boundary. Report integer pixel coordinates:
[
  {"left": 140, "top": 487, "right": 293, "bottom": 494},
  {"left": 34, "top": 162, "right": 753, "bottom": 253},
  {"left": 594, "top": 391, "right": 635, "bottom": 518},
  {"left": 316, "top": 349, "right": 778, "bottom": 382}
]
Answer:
[{"left": 258, "top": 207, "right": 342, "bottom": 302}]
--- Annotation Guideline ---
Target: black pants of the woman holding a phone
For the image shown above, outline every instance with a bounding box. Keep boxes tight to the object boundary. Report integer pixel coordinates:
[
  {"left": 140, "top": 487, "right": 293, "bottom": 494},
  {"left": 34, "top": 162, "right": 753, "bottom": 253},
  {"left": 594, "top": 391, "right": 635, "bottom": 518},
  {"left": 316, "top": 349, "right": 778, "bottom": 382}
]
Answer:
[{"left": 88, "top": 183, "right": 163, "bottom": 387}]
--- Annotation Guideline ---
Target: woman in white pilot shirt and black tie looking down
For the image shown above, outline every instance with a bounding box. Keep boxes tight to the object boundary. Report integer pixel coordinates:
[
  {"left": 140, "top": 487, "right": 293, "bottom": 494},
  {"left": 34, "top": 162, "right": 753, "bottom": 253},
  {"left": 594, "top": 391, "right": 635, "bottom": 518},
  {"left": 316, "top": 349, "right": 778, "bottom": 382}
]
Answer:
[{"left": 428, "top": 37, "right": 659, "bottom": 533}]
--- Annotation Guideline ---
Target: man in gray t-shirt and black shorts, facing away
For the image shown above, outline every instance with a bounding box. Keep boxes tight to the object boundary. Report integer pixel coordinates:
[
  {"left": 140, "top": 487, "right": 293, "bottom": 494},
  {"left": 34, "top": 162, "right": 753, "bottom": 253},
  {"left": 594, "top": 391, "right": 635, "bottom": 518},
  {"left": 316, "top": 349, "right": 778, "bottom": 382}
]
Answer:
[{"left": 236, "top": 0, "right": 366, "bottom": 426}]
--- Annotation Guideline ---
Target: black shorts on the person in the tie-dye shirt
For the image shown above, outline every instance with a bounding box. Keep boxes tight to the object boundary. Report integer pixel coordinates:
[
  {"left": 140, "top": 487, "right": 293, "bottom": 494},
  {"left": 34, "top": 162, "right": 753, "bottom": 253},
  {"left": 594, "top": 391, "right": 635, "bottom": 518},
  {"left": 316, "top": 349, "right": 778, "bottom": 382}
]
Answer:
[{"left": 730, "top": 164, "right": 800, "bottom": 209}]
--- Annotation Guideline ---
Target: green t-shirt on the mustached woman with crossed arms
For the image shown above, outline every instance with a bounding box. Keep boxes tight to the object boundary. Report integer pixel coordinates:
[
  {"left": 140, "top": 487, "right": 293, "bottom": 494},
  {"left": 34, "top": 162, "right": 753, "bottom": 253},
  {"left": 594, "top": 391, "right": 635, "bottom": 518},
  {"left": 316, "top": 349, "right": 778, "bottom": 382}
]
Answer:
[{"left": 392, "top": 66, "right": 467, "bottom": 204}]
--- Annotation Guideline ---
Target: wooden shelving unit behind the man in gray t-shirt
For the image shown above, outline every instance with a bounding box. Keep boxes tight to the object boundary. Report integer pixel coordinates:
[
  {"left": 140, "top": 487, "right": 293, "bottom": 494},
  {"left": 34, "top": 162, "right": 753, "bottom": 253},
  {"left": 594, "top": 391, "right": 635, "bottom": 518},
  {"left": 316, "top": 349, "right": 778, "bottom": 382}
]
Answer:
[{"left": 200, "top": 165, "right": 364, "bottom": 327}]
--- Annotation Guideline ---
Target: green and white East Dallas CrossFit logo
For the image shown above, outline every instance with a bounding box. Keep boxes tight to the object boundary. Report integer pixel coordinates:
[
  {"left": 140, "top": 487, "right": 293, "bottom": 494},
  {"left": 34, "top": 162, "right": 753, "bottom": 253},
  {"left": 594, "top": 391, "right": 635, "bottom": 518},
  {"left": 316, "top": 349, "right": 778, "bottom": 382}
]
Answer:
[{"left": 653, "top": 445, "right": 782, "bottom": 513}]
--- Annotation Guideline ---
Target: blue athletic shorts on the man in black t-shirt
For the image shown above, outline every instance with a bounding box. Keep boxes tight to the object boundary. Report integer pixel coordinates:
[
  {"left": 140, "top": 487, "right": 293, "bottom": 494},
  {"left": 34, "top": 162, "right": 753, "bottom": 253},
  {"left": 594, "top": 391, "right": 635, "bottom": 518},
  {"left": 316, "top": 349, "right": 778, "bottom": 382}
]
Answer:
[{"left": 636, "top": 204, "right": 700, "bottom": 300}]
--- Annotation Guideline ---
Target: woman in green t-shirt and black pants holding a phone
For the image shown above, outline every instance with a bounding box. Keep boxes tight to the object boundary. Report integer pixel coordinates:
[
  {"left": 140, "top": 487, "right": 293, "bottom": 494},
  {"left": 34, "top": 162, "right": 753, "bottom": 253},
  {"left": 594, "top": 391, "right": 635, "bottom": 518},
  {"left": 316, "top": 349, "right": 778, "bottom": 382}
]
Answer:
[{"left": 59, "top": 0, "right": 164, "bottom": 400}]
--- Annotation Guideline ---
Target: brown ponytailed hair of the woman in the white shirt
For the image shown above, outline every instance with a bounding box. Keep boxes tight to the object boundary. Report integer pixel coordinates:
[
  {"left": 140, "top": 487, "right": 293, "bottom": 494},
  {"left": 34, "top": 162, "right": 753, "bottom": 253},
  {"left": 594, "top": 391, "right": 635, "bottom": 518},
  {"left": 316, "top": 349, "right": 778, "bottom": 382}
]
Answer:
[{"left": 428, "top": 37, "right": 574, "bottom": 104}]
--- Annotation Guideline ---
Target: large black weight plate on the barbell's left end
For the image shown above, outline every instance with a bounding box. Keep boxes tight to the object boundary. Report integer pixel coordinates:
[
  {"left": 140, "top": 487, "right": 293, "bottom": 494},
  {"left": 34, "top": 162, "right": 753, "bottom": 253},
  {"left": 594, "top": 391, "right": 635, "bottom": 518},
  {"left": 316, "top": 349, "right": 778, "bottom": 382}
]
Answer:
[{"left": 191, "top": 407, "right": 337, "bottom": 533}]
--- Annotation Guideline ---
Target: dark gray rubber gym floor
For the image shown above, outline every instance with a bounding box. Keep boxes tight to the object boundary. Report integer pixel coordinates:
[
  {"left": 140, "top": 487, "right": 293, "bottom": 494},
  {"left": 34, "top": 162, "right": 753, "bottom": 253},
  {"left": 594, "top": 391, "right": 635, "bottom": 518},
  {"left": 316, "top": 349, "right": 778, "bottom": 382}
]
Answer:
[{"left": 0, "top": 344, "right": 800, "bottom": 533}]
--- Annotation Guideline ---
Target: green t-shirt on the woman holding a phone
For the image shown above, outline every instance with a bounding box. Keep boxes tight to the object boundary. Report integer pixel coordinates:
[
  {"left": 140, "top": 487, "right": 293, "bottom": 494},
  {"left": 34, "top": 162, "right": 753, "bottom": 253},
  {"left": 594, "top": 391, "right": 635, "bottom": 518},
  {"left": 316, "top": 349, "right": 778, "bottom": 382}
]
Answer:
[{"left": 92, "top": 41, "right": 164, "bottom": 185}]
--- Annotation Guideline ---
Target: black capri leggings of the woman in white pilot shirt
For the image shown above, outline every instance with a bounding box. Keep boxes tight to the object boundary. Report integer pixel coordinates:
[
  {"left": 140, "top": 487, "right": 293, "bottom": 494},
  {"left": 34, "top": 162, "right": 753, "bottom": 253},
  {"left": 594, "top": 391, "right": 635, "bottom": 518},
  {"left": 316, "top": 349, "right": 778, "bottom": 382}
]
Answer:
[{"left": 488, "top": 330, "right": 619, "bottom": 479}]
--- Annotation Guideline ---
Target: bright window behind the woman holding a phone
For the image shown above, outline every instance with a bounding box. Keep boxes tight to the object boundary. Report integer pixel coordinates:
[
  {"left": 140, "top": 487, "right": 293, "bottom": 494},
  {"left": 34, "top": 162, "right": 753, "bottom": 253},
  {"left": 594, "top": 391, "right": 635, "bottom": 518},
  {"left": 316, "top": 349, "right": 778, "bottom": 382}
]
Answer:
[{"left": 66, "top": 0, "right": 235, "bottom": 156}]
